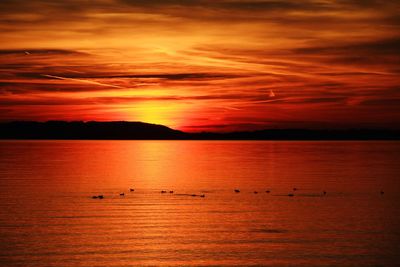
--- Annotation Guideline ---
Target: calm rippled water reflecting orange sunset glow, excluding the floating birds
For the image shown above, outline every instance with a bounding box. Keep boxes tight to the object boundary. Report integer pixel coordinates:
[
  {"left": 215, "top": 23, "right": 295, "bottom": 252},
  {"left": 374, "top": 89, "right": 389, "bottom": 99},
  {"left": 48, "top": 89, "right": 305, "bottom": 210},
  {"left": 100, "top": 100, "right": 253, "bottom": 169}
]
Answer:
[{"left": 0, "top": 141, "right": 400, "bottom": 266}]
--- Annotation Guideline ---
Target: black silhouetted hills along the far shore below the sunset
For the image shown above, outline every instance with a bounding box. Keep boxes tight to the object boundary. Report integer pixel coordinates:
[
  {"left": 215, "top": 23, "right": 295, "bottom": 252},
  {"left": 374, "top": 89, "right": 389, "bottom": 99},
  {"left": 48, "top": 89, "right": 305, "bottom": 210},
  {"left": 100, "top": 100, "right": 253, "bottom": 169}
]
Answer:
[{"left": 0, "top": 121, "right": 400, "bottom": 140}]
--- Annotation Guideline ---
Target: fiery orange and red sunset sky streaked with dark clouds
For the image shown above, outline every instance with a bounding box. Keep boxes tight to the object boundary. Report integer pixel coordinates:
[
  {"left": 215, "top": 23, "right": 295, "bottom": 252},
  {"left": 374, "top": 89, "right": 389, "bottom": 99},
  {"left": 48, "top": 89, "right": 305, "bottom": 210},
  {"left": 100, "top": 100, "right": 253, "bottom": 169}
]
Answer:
[{"left": 0, "top": 0, "right": 400, "bottom": 132}]
